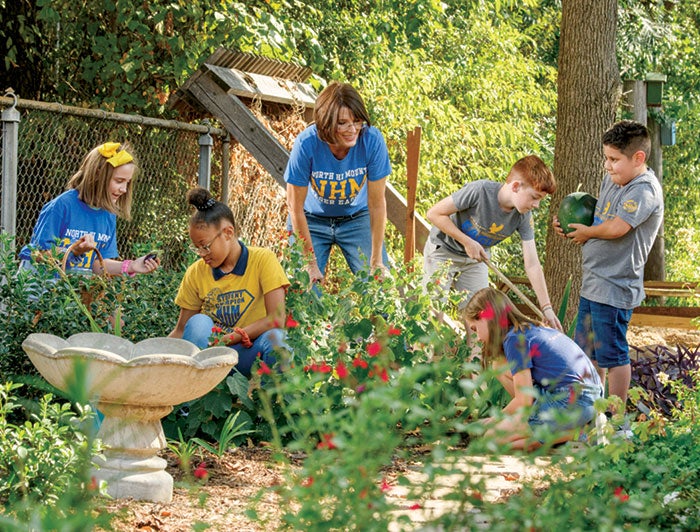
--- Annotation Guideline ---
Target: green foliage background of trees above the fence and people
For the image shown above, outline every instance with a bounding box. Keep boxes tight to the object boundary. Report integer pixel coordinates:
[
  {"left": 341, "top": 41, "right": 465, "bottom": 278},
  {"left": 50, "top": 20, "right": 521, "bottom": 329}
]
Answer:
[{"left": 0, "top": 0, "right": 700, "bottom": 280}]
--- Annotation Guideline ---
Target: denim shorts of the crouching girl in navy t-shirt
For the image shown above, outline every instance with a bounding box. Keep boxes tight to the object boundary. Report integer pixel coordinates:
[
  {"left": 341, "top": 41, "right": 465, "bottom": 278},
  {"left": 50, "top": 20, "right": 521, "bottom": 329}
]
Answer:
[{"left": 528, "top": 385, "right": 603, "bottom": 432}]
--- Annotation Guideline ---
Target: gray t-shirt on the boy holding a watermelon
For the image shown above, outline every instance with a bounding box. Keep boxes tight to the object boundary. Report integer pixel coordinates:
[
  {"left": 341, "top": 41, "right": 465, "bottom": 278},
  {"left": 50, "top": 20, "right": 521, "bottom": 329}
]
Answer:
[{"left": 581, "top": 169, "right": 664, "bottom": 309}]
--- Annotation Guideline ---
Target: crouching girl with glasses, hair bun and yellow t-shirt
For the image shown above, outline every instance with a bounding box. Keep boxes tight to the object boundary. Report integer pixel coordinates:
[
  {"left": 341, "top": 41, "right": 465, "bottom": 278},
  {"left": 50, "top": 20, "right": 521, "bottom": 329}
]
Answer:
[{"left": 169, "top": 187, "right": 289, "bottom": 377}]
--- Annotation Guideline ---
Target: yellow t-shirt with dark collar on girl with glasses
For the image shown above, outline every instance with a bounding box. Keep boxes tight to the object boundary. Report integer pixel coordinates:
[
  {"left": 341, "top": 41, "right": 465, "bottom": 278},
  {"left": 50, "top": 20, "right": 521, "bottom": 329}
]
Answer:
[{"left": 175, "top": 242, "right": 289, "bottom": 333}]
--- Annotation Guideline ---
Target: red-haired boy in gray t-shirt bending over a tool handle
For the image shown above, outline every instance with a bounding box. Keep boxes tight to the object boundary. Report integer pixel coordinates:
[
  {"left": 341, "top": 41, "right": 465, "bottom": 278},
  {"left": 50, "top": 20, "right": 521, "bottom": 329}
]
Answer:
[{"left": 423, "top": 155, "right": 561, "bottom": 330}]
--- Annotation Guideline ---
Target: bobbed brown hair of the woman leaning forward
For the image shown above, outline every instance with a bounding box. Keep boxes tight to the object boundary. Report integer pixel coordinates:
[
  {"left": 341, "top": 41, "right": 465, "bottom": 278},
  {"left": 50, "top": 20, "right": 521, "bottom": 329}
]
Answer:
[{"left": 314, "top": 81, "right": 372, "bottom": 144}]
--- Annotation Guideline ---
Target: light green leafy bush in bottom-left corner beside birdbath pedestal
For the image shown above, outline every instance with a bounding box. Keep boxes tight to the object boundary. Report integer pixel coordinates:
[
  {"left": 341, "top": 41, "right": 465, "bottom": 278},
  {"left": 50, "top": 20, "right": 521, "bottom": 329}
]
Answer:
[{"left": 0, "top": 383, "right": 109, "bottom": 531}]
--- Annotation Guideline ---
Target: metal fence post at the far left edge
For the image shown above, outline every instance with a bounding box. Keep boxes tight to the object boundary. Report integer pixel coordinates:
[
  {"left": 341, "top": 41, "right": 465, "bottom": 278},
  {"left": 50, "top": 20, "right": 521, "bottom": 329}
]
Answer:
[{"left": 0, "top": 91, "right": 20, "bottom": 245}]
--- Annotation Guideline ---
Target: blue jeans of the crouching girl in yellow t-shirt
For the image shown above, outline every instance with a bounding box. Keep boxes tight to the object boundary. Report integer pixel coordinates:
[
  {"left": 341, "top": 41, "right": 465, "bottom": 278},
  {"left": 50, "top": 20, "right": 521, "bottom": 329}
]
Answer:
[{"left": 182, "top": 314, "right": 289, "bottom": 378}]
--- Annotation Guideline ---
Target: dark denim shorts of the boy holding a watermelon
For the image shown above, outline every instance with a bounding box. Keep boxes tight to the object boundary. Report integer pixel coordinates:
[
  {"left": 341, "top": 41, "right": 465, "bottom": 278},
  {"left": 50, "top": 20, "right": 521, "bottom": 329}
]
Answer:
[{"left": 574, "top": 297, "right": 632, "bottom": 368}]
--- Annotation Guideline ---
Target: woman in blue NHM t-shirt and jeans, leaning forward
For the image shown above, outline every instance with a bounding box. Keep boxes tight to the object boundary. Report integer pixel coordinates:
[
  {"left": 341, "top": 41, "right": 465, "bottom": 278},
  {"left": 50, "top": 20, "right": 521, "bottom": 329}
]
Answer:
[{"left": 284, "top": 82, "right": 391, "bottom": 282}]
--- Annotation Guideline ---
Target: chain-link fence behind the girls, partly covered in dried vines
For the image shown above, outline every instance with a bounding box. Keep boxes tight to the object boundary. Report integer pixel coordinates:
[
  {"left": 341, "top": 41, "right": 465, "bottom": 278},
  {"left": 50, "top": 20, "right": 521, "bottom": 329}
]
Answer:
[{"left": 0, "top": 98, "right": 305, "bottom": 268}]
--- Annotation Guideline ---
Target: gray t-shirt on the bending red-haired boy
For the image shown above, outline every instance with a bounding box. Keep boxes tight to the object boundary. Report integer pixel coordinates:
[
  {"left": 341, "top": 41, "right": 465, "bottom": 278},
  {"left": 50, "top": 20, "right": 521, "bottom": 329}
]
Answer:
[{"left": 430, "top": 179, "right": 535, "bottom": 257}]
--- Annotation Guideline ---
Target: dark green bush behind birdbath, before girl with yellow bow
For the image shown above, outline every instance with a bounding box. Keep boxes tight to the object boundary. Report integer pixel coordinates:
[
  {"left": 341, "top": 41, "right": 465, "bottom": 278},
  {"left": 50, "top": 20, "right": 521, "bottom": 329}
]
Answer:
[{"left": 0, "top": 233, "right": 182, "bottom": 381}]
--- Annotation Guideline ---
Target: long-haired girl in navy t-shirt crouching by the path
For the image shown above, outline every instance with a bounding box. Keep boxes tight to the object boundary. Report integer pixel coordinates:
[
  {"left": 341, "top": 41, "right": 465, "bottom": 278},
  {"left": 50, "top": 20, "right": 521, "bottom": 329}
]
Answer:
[{"left": 464, "top": 287, "right": 603, "bottom": 450}]
